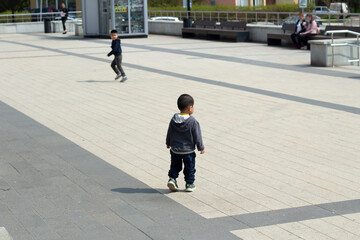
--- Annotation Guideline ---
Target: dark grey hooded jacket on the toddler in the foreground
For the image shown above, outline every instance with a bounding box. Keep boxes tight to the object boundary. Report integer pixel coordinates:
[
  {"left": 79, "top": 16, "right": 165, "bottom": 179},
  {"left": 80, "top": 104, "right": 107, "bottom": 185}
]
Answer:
[{"left": 166, "top": 113, "right": 204, "bottom": 154}]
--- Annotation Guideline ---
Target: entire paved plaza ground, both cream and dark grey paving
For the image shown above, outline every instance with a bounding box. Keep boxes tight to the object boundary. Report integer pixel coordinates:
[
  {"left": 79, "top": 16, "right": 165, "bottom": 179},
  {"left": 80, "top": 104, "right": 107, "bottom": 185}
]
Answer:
[{"left": 0, "top": 34, "right": 360, "bottom": 240}]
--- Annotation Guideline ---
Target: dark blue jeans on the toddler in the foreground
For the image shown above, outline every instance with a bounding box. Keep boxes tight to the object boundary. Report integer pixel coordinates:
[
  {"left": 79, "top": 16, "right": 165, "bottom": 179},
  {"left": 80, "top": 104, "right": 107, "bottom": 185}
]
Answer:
[{"left": 169, "top": 151, "right": 196, "bottom": 184}]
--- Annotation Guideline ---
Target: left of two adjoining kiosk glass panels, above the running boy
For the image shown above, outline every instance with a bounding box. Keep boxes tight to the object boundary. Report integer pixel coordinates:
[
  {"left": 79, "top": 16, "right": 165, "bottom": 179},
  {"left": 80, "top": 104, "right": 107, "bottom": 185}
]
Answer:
[{"left": 114, "top": 0, "right": 129, "bottom": 34}]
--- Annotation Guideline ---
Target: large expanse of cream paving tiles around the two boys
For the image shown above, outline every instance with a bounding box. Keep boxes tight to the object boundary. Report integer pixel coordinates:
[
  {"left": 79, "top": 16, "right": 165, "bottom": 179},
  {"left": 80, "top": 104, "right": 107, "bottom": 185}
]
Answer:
[{"left": 0, "top": 35, "right": 360, "bottom": 240}]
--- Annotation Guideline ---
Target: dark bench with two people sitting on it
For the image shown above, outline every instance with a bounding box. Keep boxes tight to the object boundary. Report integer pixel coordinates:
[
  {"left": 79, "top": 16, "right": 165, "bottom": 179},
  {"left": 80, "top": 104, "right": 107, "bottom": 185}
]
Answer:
[{"left": 267, "top": 23, "right": 360, "bottom": 46}]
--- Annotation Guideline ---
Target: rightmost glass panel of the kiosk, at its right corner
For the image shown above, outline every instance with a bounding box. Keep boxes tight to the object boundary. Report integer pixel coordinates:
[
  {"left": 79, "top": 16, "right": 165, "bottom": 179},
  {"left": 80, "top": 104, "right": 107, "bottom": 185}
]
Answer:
[{"left": 130, "top": 0, "right": 145, "bottom": 33}]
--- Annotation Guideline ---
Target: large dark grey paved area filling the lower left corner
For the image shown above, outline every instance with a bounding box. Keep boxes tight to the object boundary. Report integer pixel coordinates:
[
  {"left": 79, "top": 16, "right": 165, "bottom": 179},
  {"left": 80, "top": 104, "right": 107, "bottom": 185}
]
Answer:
[{"left": 0, "top": 102, "right": 242, "bottom": 240}]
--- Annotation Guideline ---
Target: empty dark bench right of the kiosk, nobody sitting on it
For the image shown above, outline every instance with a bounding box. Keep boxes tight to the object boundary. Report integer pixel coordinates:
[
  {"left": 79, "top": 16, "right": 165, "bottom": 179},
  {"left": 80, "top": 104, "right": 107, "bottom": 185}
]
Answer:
[{"left": 182, "top": 20, "right": 249, "bottom": 42}]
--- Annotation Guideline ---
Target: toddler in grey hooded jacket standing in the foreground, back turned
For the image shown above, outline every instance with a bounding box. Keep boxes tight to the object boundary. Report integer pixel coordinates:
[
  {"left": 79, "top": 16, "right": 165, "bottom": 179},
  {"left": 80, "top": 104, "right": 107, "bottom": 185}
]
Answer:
[{"left": 166, "top": 94, "right": 205, "bottom": 192}]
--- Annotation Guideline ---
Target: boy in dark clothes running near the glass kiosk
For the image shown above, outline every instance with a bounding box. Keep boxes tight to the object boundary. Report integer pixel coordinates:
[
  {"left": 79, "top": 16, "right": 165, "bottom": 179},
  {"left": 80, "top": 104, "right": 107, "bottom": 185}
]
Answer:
[{"left": 108, "top": 30, "right": 127, "bottom": 82}]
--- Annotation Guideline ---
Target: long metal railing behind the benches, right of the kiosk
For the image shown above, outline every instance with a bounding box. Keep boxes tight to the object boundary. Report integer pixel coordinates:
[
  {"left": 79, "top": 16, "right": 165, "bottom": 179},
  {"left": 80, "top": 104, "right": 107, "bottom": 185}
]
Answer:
[{"left": 148, "top": 10, "right": 360, "bottom": 26}]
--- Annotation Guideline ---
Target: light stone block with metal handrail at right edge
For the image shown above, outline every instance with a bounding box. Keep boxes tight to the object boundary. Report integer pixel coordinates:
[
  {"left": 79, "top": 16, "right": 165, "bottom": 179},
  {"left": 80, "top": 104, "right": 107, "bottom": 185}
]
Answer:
[{"left": 309, "top": 38, "right": 359, "bottom": 67}]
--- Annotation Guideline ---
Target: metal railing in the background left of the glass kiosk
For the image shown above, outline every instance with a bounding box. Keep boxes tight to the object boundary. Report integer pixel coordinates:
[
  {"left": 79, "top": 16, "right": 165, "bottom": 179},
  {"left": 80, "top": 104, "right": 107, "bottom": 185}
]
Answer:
[{"left": 0, "top": 11, "right": 82, "bottom": 23}]
